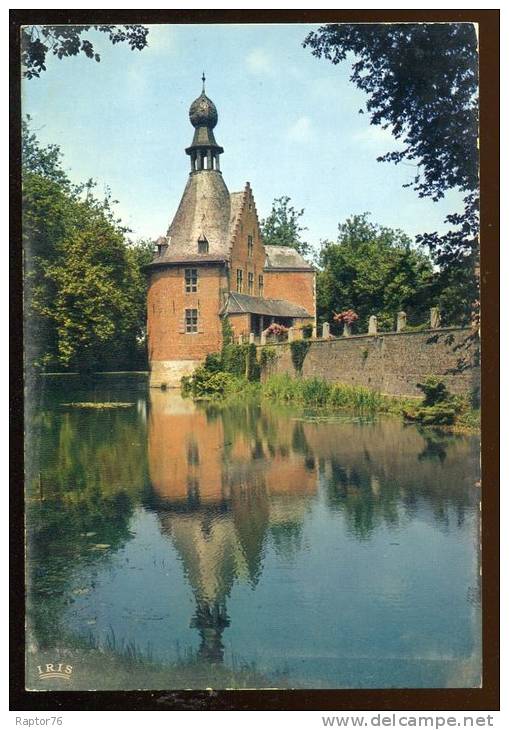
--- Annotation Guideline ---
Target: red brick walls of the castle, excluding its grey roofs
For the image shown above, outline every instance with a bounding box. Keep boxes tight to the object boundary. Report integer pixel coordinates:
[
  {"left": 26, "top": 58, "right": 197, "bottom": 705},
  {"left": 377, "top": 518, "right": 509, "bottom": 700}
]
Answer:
[{"left": 147, "top": 183, "right": 315, "bottom": 387}]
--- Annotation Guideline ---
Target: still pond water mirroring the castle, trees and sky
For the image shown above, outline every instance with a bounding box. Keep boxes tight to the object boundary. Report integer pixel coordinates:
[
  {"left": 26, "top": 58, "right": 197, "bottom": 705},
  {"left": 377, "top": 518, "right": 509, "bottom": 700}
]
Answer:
[{"left": 27, "top": 379, "right": 481, "bottom": 689}]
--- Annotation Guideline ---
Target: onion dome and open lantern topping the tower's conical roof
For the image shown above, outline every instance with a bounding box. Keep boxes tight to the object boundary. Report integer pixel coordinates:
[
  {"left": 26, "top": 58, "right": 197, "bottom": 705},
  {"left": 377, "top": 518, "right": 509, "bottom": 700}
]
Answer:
[{"left": 186, "top": 72, "right": 224, "bottom": 173}]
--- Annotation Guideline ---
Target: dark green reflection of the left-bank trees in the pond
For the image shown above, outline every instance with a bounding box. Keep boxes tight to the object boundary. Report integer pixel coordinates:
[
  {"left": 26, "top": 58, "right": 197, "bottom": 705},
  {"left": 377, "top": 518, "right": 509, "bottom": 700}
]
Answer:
[{"left": 26, "top": 389, "right": 147, "bottom": 646}]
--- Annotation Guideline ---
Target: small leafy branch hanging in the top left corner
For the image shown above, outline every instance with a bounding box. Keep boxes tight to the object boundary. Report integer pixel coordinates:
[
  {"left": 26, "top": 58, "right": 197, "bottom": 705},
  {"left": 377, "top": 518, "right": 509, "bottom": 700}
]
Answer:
[{"left": 21, "top": 25, "right": 148, "bottom": 79}]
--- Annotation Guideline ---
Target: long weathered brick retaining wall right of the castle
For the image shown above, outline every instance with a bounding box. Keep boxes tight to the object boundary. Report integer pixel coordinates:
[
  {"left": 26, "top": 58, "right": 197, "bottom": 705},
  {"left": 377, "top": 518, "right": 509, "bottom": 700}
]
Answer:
[{"left": 264, "top": 328, "right": 480, "bottom": 396}]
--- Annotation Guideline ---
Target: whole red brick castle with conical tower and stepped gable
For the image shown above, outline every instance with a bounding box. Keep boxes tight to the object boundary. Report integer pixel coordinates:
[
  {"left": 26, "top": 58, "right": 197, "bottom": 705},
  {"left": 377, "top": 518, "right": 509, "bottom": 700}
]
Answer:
[{"left": 147, "top": 77, "right": 316, "bottom": 388}]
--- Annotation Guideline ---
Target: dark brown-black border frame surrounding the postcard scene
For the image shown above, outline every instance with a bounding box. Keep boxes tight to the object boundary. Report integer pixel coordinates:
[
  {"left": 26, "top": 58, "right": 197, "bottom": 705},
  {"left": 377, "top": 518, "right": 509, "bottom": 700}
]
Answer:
[{"left": 9, "top": 9, "right": 500, "bottom": 711}]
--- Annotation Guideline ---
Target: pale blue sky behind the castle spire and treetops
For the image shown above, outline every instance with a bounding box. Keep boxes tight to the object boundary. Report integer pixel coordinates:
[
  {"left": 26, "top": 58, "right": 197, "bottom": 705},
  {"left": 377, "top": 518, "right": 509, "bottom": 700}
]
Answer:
[{"left": 22, "top": 24, "right": 461, "bottom": 252}]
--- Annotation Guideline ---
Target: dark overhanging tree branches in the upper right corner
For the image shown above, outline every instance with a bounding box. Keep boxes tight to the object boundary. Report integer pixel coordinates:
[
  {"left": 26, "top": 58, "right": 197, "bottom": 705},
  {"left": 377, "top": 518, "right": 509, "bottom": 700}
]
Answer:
[{"left": 304, "top": 23, "right": 479, "bottom": 319}]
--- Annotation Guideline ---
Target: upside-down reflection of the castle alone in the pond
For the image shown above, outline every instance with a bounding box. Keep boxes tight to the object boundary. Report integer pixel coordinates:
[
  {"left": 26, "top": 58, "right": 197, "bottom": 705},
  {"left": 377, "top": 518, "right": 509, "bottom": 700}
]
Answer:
[{"left": 147, "top": 389, "right": 316, "bottom": 662}]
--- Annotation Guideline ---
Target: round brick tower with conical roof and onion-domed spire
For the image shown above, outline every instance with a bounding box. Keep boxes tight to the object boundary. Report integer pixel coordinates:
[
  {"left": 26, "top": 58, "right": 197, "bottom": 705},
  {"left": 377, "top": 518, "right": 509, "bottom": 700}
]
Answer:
[{"left": 147, "top": 78, "right": 230, "bottom": 387}]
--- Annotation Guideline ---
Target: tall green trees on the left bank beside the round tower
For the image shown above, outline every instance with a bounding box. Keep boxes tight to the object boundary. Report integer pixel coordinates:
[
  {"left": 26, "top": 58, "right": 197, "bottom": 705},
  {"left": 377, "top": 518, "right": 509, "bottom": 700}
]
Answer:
[{"left": 22, "top": 122, "right": 151, "bottom": 371}]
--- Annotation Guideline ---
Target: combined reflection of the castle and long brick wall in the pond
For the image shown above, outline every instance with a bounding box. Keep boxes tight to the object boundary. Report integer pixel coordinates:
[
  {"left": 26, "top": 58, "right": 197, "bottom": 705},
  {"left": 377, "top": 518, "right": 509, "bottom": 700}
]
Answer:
[{"left": 144, "top": 391, "right": 478, "bottom": 676}]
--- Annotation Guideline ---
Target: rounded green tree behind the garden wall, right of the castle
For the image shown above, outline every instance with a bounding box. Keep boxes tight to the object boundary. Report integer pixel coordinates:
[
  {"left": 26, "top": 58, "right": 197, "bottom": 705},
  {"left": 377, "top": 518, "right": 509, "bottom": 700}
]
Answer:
[{"left": 317, "top": 213, "right": 433, "bottom": 331}]
